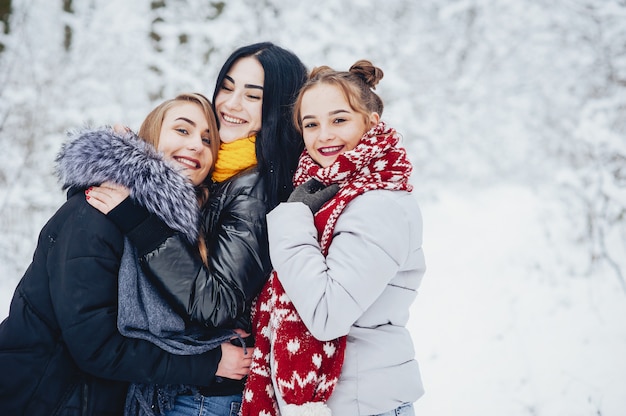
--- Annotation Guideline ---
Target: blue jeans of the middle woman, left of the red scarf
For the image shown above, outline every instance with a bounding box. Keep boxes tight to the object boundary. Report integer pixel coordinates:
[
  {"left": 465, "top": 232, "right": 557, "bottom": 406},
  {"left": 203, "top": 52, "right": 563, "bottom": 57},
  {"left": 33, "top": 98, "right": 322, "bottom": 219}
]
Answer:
[{"left": 164, "top": 394, "right": 241, "bottom": 416}]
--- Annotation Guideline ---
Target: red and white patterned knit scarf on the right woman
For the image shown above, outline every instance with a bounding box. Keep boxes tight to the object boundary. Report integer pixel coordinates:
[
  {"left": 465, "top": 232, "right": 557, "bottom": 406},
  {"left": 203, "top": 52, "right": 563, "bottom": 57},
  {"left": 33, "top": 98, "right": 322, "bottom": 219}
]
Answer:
[{"left": 241, "top": 122, "right": 412, "bottom": 416}]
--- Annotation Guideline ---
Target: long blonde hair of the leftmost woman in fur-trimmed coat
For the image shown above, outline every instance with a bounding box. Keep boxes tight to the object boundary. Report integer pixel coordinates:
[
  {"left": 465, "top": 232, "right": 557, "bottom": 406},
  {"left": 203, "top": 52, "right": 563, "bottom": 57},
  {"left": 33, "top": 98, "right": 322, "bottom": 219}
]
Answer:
[{"left": 138, "top": 93, "right": 220, "bottom": 265}]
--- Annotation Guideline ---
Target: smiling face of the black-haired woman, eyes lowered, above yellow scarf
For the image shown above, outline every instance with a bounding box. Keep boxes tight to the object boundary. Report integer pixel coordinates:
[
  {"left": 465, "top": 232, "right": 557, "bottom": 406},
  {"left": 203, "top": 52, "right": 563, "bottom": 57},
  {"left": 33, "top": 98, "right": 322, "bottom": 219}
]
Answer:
[{"left": 215, "top": 57, "right": 265, "bottom": 143}]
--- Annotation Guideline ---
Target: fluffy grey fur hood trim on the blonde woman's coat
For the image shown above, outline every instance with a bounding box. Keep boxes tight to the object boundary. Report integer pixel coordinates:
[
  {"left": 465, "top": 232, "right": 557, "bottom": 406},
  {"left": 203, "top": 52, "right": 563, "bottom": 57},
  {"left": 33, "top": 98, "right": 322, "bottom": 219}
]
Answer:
[{"left": 55, "top": 128, "right": 200, "bottom": 242}]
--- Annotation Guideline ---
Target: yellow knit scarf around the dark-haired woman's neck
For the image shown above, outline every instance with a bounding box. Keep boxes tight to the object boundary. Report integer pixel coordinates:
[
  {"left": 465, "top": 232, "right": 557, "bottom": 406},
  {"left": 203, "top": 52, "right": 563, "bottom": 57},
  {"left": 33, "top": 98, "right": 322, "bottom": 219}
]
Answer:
[{"left": 212, "top": 136, "right": 256, "bottom": 182}]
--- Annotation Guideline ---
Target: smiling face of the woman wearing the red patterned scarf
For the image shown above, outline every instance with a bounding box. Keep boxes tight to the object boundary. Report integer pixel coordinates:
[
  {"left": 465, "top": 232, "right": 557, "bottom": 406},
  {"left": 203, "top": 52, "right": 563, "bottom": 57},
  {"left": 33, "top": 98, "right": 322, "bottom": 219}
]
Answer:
[{"left": 300, "top": 84, "right": 379, "bottom": 167}]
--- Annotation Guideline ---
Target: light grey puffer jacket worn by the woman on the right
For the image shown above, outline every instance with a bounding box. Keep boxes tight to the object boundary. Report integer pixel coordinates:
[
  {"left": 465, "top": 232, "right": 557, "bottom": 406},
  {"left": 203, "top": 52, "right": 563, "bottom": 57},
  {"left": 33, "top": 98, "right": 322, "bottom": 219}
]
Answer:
[{"left": 268, "top": 190, "right": 426, "bottom": 415}]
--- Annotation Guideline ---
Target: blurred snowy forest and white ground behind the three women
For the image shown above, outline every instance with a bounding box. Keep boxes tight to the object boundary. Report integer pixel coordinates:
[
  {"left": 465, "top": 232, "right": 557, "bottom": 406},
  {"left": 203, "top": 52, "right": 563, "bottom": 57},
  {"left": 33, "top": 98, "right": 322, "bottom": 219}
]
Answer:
[{"left": 0, "top": 0, "right": 626, "bottom": 416}]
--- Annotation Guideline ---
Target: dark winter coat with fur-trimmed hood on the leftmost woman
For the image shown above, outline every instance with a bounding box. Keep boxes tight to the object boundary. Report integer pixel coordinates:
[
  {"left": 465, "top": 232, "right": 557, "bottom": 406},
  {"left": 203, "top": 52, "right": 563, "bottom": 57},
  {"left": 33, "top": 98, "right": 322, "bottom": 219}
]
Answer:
[{"left": 0, "top": 131, "right": 221, "bottom": 416}]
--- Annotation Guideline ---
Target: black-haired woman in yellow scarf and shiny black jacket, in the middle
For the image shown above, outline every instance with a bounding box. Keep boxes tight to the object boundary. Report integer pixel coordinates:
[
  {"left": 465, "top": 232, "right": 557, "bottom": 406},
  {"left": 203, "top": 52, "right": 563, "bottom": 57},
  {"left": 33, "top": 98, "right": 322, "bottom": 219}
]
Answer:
[{"left": 90, "top": 42, "right": 307, "bottom": 416}]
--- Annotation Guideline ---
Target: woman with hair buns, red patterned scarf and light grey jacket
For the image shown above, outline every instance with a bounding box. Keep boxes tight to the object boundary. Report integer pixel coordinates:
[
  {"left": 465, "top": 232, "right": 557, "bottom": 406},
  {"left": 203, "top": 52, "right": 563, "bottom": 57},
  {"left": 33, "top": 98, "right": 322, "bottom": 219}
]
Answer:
[{"left": 242, "top": 60, "right": 425, "bottom": 416}]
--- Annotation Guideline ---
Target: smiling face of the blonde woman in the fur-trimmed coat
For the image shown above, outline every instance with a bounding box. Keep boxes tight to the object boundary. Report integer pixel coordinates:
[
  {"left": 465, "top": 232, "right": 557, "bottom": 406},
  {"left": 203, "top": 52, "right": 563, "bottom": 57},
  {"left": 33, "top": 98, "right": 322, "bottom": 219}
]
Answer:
[{"left": 157, "top": 102, "right": 215, "bottom": 185}]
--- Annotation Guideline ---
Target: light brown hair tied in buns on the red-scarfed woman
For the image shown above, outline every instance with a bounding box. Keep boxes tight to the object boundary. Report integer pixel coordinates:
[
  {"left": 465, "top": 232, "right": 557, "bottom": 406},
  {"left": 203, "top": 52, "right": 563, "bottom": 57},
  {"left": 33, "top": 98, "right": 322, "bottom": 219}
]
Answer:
[{"left": 293, "top": 59, "right": 384, "bottom": 134}]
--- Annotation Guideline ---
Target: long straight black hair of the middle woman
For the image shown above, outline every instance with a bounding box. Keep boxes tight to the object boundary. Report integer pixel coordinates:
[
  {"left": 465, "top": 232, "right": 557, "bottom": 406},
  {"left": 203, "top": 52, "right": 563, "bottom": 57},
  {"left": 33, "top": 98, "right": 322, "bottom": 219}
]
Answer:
[{"left": 213, "top": 42, "right": 307, "bottom": 208}]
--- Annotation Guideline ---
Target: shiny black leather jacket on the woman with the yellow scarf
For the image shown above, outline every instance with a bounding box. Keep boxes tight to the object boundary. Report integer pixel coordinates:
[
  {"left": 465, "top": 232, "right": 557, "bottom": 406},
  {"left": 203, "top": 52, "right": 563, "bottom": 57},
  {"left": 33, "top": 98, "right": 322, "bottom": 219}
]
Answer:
[{"left": 119, "top": 168, "right": 271, "bottom": 332}]
